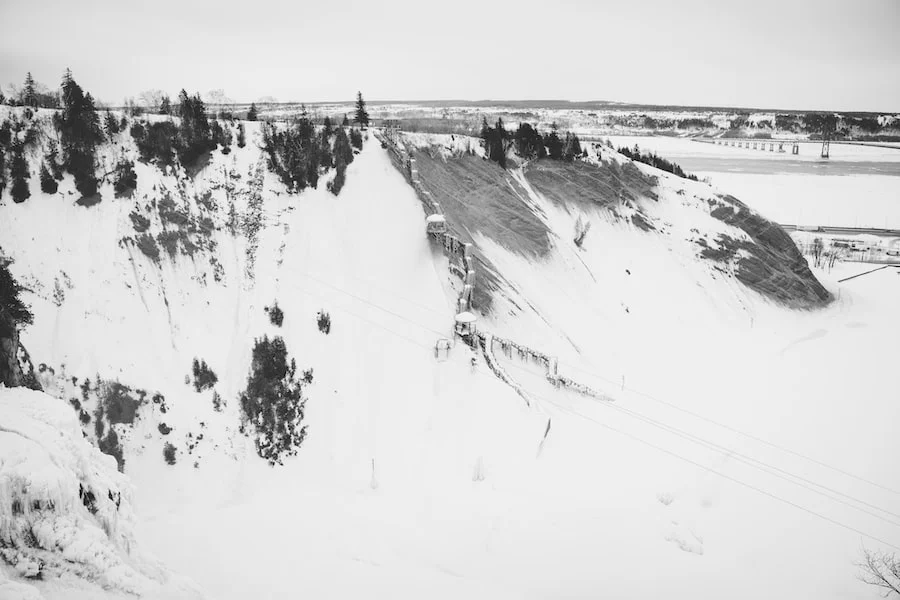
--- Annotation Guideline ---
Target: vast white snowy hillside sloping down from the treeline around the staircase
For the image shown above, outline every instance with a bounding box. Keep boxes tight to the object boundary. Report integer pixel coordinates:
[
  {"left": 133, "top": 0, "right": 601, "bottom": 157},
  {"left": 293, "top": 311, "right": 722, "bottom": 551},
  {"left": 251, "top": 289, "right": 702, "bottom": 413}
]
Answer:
[{"left": 0, "top": 109, "right": 900, "bottom": 599}]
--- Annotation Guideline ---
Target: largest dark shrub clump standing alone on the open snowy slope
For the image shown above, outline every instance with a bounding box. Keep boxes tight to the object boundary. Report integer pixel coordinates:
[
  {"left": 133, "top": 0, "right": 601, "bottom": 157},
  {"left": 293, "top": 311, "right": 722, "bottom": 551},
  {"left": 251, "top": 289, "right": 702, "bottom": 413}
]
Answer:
[{"left": 241, "top": 336, "right": 306, "bottom": 465}]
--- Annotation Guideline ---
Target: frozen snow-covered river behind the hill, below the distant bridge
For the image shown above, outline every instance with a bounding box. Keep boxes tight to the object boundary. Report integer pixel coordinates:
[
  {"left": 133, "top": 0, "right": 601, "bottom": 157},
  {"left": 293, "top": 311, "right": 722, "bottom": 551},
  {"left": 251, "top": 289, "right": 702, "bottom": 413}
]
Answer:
[{"left": 609, "top": 136, "right": 900, "bottom": 229}]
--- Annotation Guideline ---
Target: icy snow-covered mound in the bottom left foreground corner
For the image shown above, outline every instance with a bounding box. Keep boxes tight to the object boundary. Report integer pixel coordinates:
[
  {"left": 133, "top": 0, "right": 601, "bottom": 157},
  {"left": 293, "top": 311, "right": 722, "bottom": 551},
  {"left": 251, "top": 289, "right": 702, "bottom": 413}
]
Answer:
[{"left": 0, "top": 388, "right": 201, "bottom": 599}]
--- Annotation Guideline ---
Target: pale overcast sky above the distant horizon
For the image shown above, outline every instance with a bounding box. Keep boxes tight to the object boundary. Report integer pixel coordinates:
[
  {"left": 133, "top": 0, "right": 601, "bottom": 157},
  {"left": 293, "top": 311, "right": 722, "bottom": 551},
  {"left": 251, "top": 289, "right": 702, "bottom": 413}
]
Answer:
[{"left": 0, "top": 0, "right": 900, "bottom": 112}]
